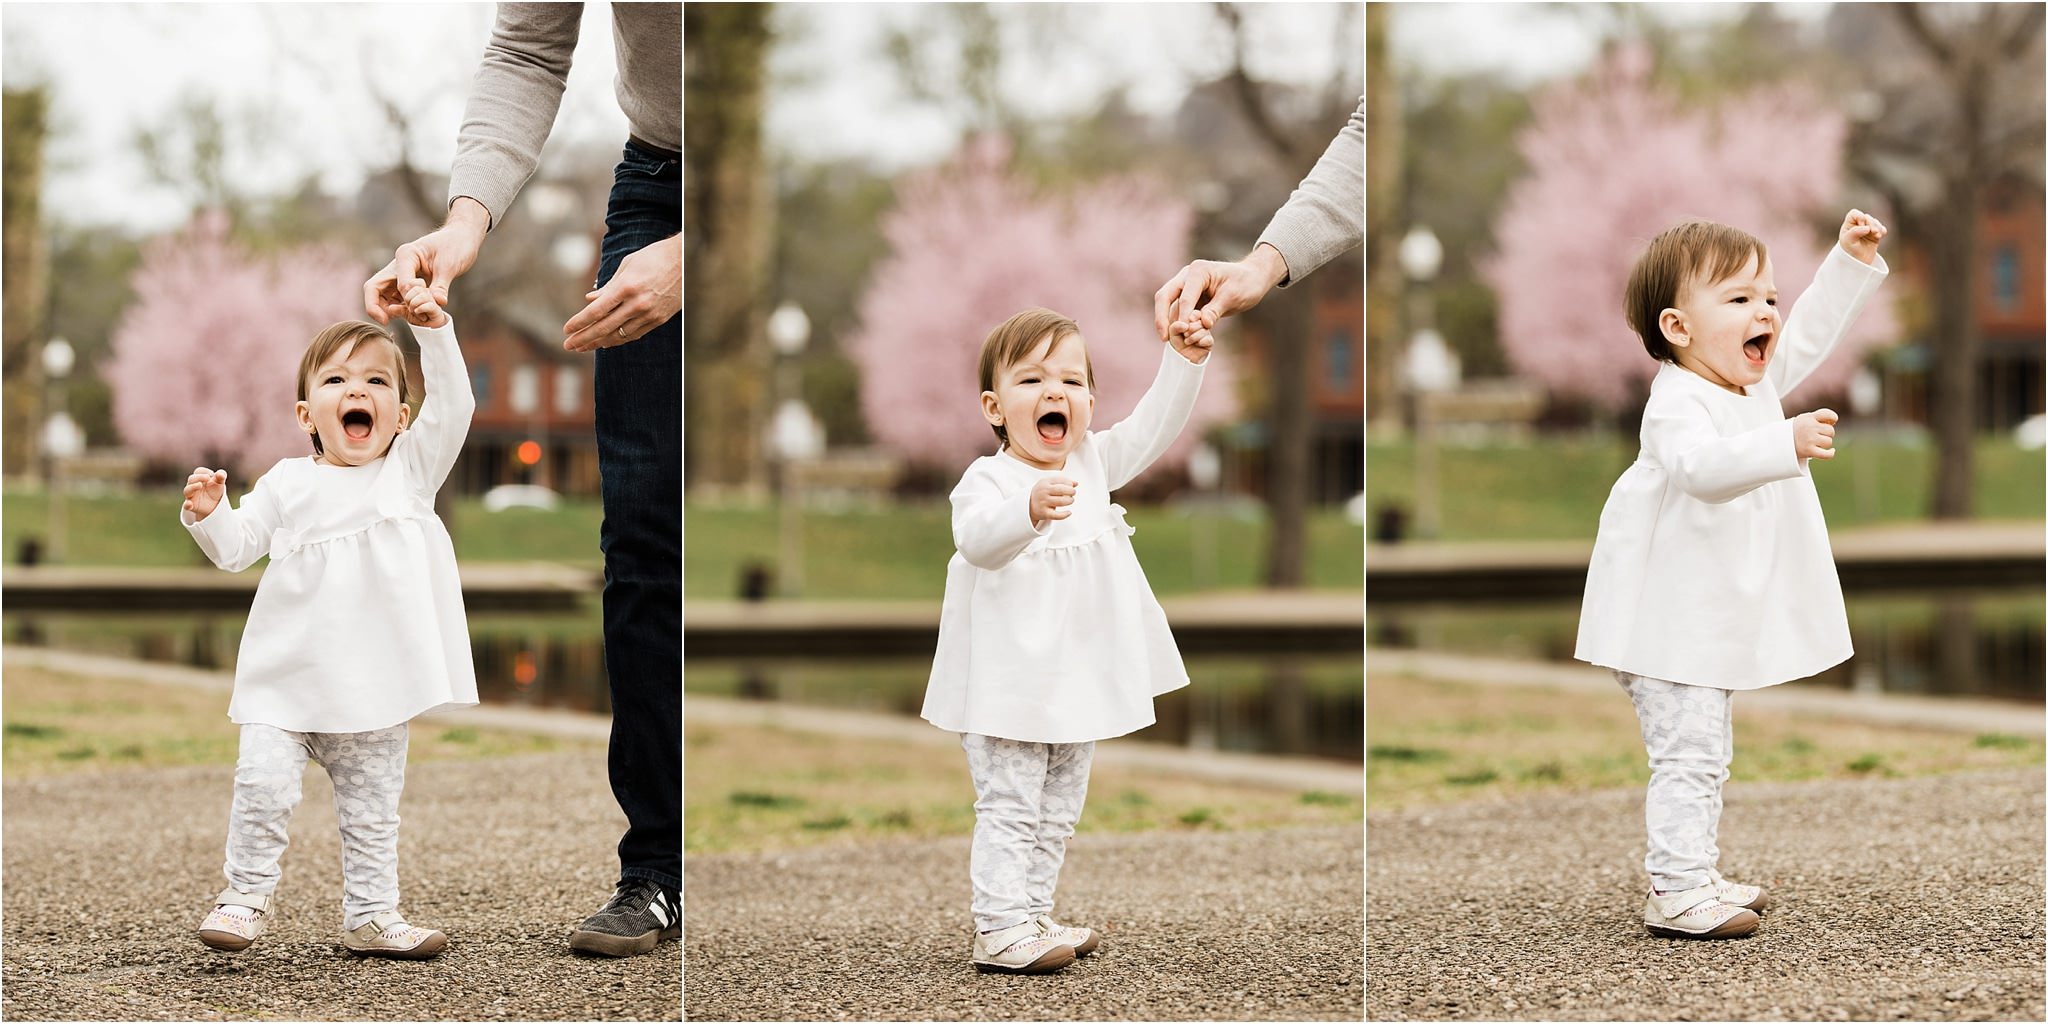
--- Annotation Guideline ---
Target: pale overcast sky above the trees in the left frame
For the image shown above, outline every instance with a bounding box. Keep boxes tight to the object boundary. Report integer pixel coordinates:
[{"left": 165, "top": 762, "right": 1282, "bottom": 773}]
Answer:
[{"left": 0, "top": 4, "right": 627, "bottom": 231}]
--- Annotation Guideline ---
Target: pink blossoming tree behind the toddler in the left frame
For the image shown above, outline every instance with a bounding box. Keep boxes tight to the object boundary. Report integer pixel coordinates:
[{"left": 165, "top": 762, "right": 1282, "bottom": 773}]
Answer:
[{"left": 102, "top": 213, "right": 362, "bottom": 483}]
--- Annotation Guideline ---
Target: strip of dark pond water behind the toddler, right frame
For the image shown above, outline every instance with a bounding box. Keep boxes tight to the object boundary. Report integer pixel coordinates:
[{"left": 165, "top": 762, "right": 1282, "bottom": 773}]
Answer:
[{"left": 1366, "top": 588, "right": 2048, "bottom": 700}]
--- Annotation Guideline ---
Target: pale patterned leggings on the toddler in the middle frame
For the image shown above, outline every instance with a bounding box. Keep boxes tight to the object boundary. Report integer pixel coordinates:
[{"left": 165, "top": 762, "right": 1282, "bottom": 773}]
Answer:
[{"left": 961, "top": 733, "right": 1096, "bottom": 932}]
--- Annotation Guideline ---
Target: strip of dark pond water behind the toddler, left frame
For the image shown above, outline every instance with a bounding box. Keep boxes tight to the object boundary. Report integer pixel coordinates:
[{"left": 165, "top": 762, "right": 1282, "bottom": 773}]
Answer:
[{"left": 4, "top": 612, "right": 610, "bottom": 713}]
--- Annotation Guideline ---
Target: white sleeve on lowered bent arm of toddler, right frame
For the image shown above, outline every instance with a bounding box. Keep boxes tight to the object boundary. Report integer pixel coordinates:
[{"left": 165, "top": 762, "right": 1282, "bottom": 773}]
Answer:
[{"left": 1642, "top": 395, "right": 1802, "bottom": 504}]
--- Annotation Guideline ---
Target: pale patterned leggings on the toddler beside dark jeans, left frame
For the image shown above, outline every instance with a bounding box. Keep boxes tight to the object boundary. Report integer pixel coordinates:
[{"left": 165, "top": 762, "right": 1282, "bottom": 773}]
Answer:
[{"left": 227, "top": 723, "right": 406, "bottom": 928}]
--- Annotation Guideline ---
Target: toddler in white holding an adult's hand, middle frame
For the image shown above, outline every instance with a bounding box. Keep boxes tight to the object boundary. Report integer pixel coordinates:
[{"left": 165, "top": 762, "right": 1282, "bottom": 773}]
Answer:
[{"left": 924, "top": 309, "right": 1214, "bottom": 973}]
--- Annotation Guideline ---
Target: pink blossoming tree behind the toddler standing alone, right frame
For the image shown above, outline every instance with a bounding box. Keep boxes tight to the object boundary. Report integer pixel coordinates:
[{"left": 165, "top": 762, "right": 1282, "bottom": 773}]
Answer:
[{"left": 1481, "top": 45, "right": 1896, "bottom": 412}]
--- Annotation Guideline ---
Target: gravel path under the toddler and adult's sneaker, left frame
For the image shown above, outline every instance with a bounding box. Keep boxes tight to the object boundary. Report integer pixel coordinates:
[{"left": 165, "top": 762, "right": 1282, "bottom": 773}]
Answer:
[{"left": 0, "top": 750, "right": 682, "bottom": 1020}]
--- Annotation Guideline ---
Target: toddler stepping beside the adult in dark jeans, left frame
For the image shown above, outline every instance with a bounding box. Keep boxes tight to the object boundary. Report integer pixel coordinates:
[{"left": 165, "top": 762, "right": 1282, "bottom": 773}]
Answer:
[{"left": 180, "top": 287, "right": 477, "bottom": 961}]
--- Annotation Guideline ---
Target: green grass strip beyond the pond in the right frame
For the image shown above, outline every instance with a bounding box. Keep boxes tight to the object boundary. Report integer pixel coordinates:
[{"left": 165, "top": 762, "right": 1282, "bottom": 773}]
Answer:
[{"left": 1359, "top": 434, "right": 2048, "bottom": 540}]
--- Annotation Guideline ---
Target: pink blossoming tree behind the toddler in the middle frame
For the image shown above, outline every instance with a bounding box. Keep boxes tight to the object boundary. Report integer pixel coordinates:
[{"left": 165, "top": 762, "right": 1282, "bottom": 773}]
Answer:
[{"left": 848, "top": 139, "right": 1243, "bottom": 473}]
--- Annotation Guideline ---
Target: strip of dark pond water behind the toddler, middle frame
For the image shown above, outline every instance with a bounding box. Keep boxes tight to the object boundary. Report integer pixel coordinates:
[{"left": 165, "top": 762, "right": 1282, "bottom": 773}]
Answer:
[{"left": 684, "top": 655, "right": 1366, "bottom": 762}]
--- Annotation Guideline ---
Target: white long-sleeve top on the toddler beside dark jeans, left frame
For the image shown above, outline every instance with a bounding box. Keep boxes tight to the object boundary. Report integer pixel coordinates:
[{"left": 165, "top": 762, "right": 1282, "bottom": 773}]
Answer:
[{"left": 178, "top": 322, "right": 477, "bottom": 733}]
